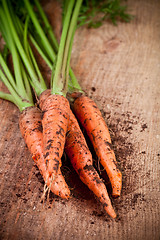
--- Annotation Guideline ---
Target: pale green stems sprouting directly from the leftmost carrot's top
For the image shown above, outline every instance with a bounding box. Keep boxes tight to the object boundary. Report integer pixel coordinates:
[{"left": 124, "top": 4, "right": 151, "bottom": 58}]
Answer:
[{"left": 0, "top": 1, "right": 34, "bottom": 111}]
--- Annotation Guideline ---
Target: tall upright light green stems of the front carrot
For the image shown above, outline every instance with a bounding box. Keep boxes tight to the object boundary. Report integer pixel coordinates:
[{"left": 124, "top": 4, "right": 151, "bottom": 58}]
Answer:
[{"left": 52, "top": 0, "right": 82, "bottom": 95}]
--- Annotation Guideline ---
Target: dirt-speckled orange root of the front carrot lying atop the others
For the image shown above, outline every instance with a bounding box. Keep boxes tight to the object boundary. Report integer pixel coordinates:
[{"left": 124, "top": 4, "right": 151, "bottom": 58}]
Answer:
[{"left": 40, "top": 90, "right": 70, "bottom": 180}]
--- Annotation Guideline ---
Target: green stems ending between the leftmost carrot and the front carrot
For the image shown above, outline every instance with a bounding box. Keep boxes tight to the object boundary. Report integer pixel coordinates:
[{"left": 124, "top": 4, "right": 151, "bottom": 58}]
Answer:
[{"left": 0, "top": 0, "right": 47, "bottom": 98}]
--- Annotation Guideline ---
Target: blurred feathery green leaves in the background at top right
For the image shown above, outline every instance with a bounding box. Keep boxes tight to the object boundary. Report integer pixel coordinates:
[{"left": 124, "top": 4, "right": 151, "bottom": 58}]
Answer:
[{"left": 11, "top": 0, "right": 133, "bottom": 27}]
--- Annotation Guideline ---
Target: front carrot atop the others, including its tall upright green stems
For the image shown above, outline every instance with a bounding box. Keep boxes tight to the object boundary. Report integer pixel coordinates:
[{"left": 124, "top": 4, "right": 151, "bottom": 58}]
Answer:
[{"left": 24, "top": 0, "right": 82, "bottom": 184}]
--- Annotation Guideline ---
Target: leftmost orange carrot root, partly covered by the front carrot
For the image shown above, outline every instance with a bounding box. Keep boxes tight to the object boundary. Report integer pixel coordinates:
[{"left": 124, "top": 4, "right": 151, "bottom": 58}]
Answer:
[{"left": 19, "top": 107, "right": 70, "bottom": 199}]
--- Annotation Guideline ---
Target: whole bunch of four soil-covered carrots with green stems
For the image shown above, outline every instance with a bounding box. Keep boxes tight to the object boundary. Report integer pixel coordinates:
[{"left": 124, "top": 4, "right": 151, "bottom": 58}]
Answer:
[{"left": 0, "top": 0, "right": 132, "bottom": 218}]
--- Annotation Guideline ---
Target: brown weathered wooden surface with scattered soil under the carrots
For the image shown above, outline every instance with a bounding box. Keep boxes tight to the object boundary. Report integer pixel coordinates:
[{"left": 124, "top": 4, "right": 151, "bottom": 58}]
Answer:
[{"left": 0, "top": 0, "right": 160, "bottom": 240}]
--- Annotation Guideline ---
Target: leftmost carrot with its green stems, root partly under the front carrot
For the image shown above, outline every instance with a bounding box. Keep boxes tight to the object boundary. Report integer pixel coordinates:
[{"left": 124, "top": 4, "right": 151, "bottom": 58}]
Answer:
[{"left": 0, "top": 0, "right": 69, "bottom": 198}]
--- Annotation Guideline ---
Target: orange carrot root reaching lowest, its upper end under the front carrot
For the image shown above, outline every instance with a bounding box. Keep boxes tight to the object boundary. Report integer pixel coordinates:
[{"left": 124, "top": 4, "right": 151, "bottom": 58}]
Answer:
[{"left": 65, "top": 111, "right": 116, "bottom": 218}]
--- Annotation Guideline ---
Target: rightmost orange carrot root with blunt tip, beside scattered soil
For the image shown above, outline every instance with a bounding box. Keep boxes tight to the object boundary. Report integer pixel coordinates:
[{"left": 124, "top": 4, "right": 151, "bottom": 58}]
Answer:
[{"left": 73, "top": 95, "right": 122, "bottom": 197}]
